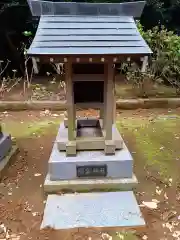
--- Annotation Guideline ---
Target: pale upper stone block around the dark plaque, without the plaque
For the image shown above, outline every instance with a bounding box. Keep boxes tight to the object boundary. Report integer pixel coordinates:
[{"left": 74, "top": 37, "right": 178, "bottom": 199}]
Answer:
[{"left": 48, "top": 124, "right": 133, "bottom": 181}]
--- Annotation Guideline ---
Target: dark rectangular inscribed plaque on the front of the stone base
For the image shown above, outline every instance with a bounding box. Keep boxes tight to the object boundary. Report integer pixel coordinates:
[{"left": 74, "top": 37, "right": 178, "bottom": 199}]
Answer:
[{"left": 76, "top": 164, "right": 107, "bottom": 178}]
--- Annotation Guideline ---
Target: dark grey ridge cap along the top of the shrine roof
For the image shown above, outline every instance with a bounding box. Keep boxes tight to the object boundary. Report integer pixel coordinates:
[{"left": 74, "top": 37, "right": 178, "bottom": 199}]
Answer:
[{"left": 27, "top": 0, "right": 146, "bottom": 18}]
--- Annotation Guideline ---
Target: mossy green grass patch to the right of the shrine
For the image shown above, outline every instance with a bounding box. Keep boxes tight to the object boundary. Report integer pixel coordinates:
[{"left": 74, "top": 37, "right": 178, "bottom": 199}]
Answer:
[{"left": 117, "top": 117, "right": 180, "bottom": 182}]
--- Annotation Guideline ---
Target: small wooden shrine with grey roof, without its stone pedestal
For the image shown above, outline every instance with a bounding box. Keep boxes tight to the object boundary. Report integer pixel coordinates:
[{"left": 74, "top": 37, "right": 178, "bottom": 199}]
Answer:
[{"left": 28, "top": 1, "right": 151, "bottom": 156}]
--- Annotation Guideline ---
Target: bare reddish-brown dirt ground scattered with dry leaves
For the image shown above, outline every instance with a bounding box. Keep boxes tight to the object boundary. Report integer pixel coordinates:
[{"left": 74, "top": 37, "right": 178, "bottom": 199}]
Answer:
[{"left": 0, "top": 110, "right": 180, "bottom": 240}]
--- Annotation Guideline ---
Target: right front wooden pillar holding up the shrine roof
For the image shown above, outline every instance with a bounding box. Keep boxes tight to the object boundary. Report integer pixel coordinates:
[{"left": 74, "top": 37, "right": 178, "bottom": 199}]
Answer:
[{"left": 105, "top": 60, "right": 114, "bottom": 140}]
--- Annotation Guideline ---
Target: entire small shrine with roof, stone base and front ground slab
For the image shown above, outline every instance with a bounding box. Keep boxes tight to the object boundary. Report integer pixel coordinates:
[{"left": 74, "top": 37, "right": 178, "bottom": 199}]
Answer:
[{"left": 28, "top": 0, "right": 151, "bottom": 231}]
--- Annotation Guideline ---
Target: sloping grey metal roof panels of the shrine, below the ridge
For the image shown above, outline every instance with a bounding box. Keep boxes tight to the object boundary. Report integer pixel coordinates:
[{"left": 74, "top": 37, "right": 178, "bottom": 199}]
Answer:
[{"left": 28, "top": 15, "right": 152, "bottom": 56}]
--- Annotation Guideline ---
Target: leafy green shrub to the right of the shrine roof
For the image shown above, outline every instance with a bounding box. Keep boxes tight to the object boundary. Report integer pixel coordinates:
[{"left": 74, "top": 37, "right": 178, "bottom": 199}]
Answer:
[{"left": 126, "top": 22, "right": 180, "bottom": 96}]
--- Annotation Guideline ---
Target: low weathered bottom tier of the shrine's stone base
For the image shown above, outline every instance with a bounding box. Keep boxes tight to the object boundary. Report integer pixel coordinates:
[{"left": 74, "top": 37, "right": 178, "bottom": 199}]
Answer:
[{"left": 44, "top": 172, "right": 138, "bottom": 193}]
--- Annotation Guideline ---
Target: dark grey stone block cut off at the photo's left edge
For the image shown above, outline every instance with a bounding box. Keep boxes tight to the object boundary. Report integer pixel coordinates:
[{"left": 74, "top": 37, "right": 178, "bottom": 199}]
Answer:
[{"left": 0, "top": 133, "right": 12, "bottom": 162}]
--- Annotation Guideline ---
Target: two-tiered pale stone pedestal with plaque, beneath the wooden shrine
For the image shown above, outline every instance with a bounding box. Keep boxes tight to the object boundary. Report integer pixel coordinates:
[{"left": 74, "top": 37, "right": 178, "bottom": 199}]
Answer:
[{"left": 45, "top": 123, "right": 137, "bottom": 192}]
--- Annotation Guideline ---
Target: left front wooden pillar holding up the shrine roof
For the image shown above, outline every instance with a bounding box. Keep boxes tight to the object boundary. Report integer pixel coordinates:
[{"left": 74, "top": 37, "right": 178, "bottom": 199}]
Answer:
[{"left": 65, "top": 59, "right": 75, "bottom": 141}]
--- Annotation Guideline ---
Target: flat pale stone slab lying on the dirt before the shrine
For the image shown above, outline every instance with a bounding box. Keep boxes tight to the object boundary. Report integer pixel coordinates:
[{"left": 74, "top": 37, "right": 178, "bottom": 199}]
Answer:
[{"left": 41, "top": 191, "right": 145, "bottom": 230}]
